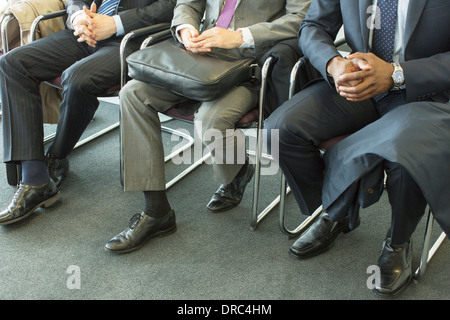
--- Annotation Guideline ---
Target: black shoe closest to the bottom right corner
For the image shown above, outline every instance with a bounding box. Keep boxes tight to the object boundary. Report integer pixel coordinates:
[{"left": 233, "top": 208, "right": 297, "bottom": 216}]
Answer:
[{"left": 373, "top": 238, "right": 412, "bottom": 298}]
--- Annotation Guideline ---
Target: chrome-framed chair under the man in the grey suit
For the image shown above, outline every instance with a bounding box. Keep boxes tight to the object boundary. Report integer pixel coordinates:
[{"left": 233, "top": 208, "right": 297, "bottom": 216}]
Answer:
[{"left": 134, "top": 30, "right": 276, "bottom": 230}]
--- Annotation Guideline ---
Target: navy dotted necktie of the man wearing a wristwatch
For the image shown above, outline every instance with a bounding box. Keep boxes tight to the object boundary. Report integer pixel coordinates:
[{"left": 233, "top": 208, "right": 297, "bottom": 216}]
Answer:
[{"left": 372, "top": 0, "right": 398, "bottom": 101}]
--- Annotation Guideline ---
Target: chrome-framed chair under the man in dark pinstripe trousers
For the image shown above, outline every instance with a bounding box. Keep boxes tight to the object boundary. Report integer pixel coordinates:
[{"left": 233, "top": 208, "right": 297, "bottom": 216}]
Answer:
[{"left": 2, "top": 6, "right": 170, "bottom": 186}]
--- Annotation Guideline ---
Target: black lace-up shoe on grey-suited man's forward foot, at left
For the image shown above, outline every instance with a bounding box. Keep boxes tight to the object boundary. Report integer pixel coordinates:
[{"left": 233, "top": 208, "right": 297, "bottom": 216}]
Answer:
[{"left": 105, "top": 210, "right": 177, "bottom": 253}]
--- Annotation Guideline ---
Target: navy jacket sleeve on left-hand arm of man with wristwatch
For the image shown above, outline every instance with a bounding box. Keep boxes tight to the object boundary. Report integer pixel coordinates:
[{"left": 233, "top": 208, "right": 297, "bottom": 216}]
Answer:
[{"left": 299, "top": 0, "right": 342, "bottom": 84}]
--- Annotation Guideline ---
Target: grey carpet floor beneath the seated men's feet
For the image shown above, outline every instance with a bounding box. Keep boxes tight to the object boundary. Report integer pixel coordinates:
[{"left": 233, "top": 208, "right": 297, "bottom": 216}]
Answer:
[{"left": 0, "top": 98, "right": 450, "bottom": 301}]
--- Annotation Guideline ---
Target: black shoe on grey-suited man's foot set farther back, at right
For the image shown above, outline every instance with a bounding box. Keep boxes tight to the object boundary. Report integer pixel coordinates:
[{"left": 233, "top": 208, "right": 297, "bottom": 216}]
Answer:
[{"left": 206, "top": 161, "right": 255, "bottom": 213}]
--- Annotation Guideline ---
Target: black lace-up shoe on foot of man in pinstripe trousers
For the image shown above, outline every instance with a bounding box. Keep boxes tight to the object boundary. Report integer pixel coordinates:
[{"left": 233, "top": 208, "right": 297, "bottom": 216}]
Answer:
[{"left": 0, "top": 179, "right": 60, "bottom": 225}]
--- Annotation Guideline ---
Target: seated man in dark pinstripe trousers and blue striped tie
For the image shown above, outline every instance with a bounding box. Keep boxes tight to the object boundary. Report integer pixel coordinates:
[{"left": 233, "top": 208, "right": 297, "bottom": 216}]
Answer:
[{"left": 0, "top": 0, "right": 176, "bottom": 225}]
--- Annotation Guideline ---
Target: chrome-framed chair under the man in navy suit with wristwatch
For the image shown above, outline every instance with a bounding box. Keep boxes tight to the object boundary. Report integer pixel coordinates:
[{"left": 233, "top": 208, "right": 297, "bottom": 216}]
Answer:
[{"left": 279, "top": 49, "right": 446, "bottom": 280}]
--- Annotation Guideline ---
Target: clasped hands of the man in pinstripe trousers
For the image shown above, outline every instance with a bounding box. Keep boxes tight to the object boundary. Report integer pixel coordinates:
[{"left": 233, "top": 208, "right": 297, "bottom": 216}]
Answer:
[{"left": 73, "top": 3, "right": 117, "bottom": 47}]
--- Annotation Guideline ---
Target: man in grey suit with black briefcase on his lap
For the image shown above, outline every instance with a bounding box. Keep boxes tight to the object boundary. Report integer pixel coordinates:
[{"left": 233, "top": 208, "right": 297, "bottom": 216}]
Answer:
[{"left": 106, "top": 0, "right": 310, "bottom": 253}]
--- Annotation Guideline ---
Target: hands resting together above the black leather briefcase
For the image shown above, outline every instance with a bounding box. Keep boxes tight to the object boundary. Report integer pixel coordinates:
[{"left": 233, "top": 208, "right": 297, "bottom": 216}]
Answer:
[{"left": 180, "top": 27, "right": 244, "bottom": 53}]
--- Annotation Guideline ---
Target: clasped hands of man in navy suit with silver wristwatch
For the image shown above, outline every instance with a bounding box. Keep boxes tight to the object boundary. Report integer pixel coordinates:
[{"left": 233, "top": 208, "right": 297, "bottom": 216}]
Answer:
[{"left": 327, "top": 52, "right": 394, "bottom": 101}]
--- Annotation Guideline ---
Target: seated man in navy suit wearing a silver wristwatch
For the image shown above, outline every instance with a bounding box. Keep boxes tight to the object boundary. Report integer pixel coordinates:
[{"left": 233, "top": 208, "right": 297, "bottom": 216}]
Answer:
[{"left": 265, "top": 0, "right": 450, "bottom": 296}]
